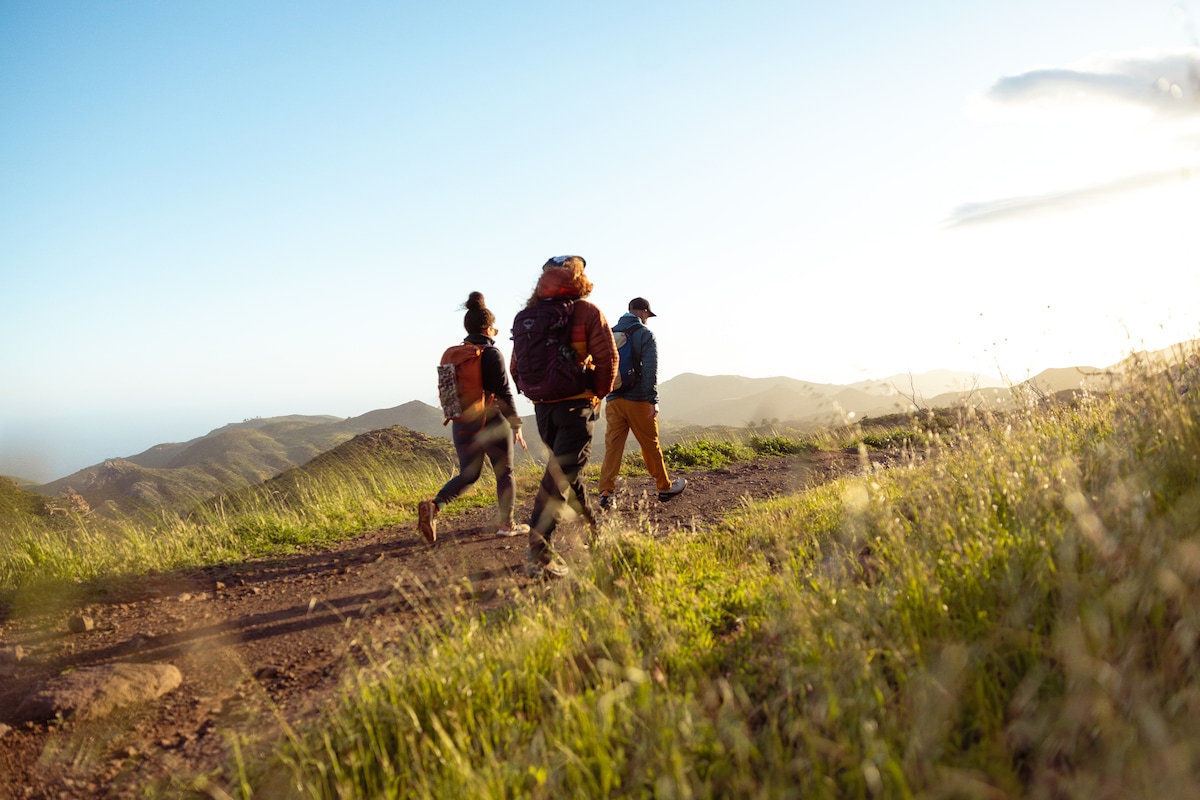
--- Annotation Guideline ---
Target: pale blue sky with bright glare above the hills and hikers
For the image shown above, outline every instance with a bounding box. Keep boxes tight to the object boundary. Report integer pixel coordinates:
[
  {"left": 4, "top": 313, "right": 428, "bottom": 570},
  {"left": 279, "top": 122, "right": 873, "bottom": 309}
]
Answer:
[{"left": 0, "top": 0, "right": 1200, "bottom": 480}]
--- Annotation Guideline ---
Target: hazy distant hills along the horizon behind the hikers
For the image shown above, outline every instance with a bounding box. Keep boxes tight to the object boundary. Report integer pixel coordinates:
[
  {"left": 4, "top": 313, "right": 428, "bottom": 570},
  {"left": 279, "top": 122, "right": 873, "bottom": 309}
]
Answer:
[{"left": 25, "top": 342, "right": 1196, "bottom": 513}]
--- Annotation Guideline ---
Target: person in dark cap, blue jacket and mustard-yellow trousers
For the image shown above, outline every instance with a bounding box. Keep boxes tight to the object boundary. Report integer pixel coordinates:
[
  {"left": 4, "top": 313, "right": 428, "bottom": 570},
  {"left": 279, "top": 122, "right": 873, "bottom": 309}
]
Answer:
[{"left": 600, "top": 297, "right": 688, "bottom": 510}]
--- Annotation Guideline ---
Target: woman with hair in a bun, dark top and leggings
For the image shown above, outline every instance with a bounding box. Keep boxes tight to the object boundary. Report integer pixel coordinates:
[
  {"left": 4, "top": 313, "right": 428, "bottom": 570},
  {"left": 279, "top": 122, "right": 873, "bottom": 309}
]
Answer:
[{"left": 416, "top": 291, "right": 529, "bottom": 545}]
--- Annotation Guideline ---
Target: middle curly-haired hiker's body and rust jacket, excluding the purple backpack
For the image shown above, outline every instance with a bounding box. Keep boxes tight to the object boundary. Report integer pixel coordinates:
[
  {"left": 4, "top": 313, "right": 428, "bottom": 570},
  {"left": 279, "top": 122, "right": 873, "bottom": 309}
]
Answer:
[{"left": 509, "top": 255, "right": 617, "bottom": 578}]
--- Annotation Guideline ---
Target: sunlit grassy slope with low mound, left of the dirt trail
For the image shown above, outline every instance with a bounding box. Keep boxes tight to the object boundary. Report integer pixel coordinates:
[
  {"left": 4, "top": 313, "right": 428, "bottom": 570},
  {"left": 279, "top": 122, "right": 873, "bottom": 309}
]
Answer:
[{"left": 0, "top": 427, "right": 456, "bottom": 594}]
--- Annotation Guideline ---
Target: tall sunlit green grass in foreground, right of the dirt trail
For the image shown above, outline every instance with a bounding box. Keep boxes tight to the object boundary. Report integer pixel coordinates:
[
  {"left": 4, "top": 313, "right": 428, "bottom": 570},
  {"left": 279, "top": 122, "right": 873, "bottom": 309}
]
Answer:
[{"left": 206, "top": 352, "right": 1200, "bottom": 798}]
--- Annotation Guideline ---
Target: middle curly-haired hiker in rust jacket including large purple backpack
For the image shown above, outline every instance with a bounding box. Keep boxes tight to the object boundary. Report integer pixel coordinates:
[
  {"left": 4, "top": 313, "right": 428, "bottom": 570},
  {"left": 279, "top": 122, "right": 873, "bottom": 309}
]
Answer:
[{"left": 511, "top": 255, "right": 617, "bottom": 578}]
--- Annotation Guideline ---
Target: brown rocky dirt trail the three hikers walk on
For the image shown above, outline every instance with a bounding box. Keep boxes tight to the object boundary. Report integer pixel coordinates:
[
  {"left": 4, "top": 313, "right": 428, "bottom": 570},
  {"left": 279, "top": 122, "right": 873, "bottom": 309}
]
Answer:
[{"left": 0, "top": 451, "right": 896, "bottom": 799}]
